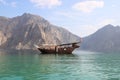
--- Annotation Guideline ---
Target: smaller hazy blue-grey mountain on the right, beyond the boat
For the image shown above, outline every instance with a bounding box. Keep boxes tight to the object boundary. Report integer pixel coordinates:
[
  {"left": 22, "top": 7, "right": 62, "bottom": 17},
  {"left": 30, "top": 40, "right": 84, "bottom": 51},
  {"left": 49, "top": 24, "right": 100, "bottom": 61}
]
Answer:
[{"left": 81, "top": 24, "right": 120, "bottom": 52}]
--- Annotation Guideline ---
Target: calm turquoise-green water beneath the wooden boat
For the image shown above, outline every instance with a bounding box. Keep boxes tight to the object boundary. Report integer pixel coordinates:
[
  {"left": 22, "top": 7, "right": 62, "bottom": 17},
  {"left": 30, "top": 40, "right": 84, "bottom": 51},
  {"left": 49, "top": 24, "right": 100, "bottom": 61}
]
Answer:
[{"left": 0, "top": 51, "right": 120, "bottom": 80}]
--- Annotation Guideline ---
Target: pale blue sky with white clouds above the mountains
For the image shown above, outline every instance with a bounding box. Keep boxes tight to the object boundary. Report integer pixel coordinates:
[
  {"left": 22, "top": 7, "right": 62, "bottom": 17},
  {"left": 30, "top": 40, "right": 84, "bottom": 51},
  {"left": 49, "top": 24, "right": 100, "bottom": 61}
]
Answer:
[{"left": 0, "top": 0, "right": 120, "bottom": 37}]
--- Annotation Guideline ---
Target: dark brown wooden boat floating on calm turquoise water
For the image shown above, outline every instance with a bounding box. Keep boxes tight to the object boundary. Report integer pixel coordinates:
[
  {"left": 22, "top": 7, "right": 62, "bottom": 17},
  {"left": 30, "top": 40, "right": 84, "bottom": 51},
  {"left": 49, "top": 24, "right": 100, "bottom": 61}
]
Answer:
[{"left": 35, "top": 42, "right": 80, "bottom": 54}]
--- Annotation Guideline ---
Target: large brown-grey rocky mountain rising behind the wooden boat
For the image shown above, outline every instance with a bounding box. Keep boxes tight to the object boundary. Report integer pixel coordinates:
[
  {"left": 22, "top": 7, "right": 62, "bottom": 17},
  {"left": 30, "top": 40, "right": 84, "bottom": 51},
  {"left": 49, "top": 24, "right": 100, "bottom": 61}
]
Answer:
[{"left": 0, "top": 13, "right": 80, "bottom": 49}]
